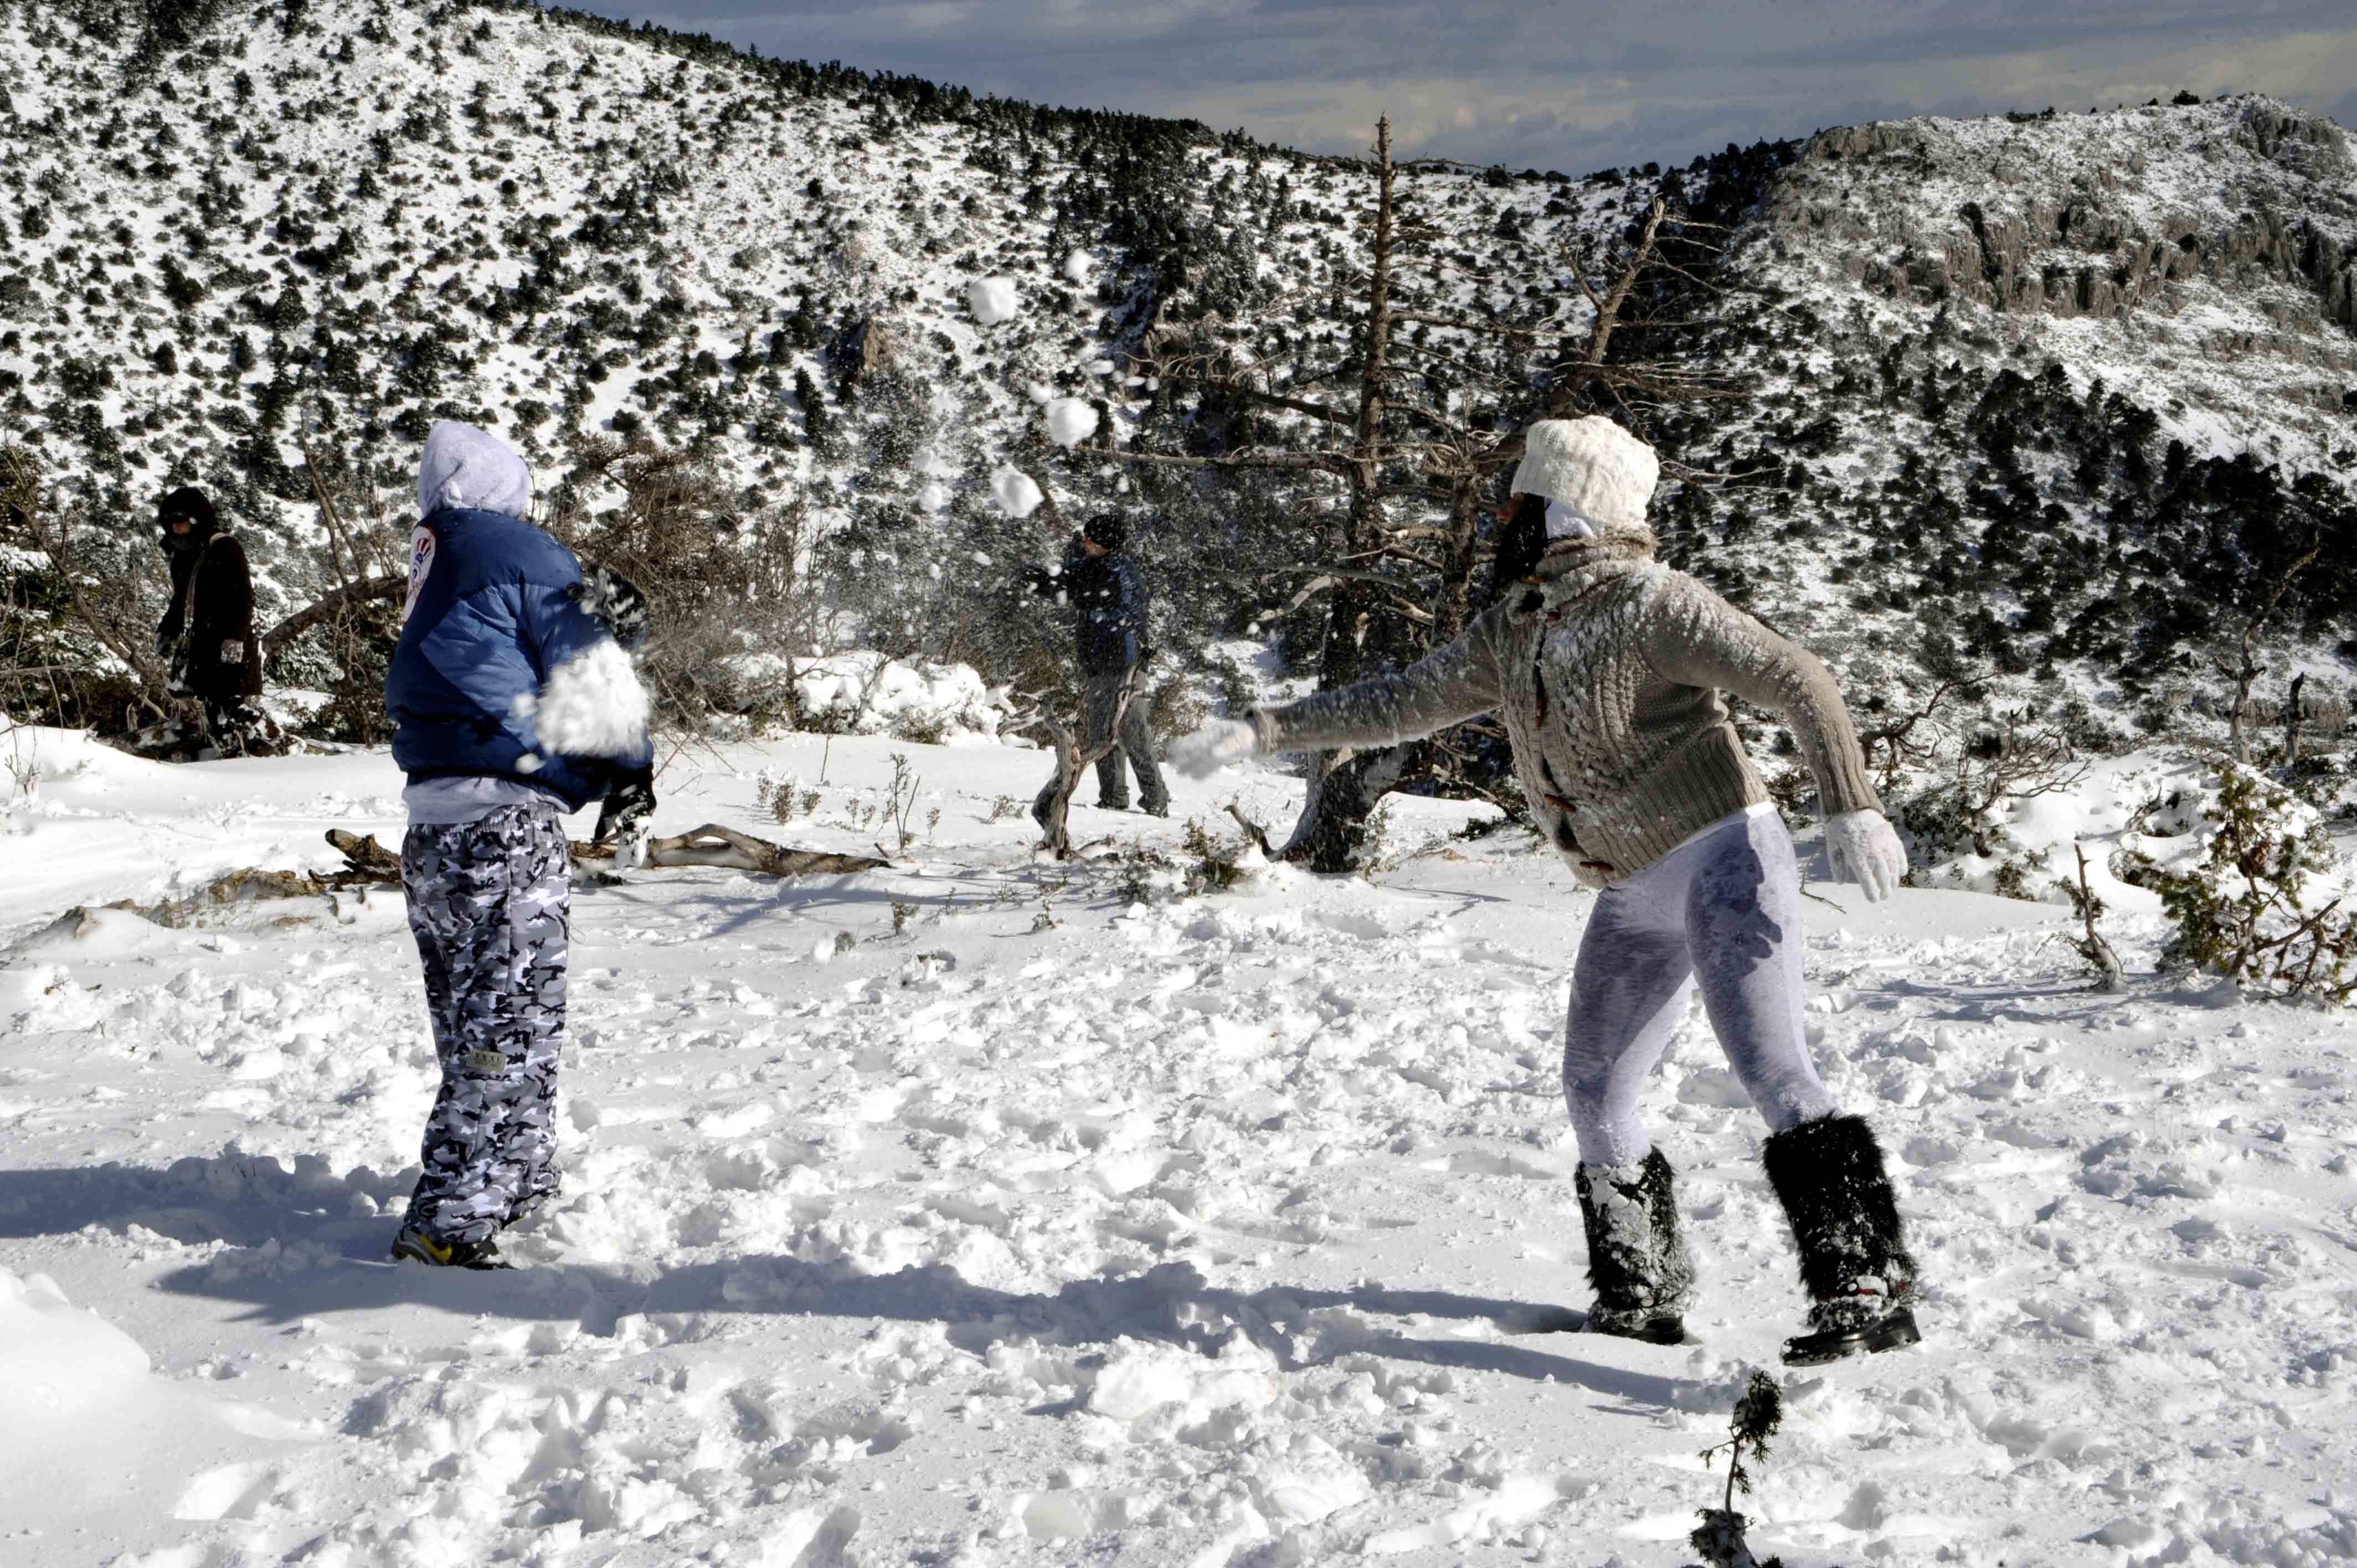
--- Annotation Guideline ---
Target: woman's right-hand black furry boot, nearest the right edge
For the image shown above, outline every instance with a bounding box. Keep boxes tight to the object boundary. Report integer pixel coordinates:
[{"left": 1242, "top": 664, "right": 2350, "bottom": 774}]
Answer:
[{"left": 1763, "top": 1115, "right": 1923, "bottom": 1368}]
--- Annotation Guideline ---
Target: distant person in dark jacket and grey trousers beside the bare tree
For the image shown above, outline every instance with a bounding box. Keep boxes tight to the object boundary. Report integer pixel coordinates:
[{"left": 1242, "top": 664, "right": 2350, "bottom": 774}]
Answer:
[{"left": 1030, "top": 512, "right": 1169, "bottom": 823}]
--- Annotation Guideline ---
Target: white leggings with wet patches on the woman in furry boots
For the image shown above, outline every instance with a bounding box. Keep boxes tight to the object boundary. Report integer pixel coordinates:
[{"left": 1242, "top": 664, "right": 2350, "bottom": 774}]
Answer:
[{"left": 1563, "top": 806, "right": 1841, "bottom": 1165}]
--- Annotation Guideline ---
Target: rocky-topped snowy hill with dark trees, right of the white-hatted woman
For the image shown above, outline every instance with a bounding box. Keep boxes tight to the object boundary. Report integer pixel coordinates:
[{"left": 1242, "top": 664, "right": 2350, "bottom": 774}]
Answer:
[{"left": 1664, "top": 97, "right": 2357, "bottom": 733}]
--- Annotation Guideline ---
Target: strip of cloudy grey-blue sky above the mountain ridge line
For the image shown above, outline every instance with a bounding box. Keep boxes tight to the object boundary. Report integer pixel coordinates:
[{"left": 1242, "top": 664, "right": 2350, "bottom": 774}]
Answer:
[{"left": 551, "top": 0, "right": 2357, "bottom": 174}]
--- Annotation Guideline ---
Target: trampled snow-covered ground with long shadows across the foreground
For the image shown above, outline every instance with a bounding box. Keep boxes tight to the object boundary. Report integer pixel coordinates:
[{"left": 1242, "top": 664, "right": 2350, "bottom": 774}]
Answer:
[{"left": 0, "top": 733, "right": 2357, "bottom": 1568}]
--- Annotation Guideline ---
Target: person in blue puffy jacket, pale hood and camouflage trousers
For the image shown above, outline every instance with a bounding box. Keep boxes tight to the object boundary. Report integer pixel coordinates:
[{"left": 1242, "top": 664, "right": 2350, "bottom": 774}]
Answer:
[{"left": 384, "top": 422, "right": 655, "bottom": 1268}]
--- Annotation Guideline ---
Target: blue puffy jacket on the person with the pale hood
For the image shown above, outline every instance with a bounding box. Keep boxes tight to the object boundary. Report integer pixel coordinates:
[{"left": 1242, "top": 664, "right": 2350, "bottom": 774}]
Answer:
[{"left": 384, "top": 509, "right": 655, "bottom": 811}]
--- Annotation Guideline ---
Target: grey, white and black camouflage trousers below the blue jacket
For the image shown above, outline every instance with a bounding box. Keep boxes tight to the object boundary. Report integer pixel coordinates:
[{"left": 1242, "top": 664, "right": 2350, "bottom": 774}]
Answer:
[{"left": 401, "top": 806, "right": 573, "bottom": 1242}]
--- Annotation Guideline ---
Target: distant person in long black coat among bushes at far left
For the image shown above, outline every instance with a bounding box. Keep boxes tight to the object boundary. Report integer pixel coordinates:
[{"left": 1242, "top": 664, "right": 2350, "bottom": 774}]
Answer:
[{"left": 156, "top": 486, "right": 261, "bottom": 755}]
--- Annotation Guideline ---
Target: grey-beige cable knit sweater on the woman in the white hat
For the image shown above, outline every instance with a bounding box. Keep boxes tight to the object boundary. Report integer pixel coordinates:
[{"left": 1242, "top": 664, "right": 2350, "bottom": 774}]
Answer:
[{"left": 1252, "top": 530, "right": 1881, "bottom": 886}]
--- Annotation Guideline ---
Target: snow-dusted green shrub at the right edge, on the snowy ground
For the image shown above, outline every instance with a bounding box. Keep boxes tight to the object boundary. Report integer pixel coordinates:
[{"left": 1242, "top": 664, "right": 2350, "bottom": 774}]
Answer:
[{"left": 2112, "top": 762, "right": 2357, "bottom": 1002}]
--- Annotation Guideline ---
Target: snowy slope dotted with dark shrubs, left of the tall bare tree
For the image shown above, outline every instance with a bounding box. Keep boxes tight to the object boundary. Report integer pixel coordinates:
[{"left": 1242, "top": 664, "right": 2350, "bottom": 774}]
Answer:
[{"left": 0, "top": 0, "right": 1622, "bottom": 726}]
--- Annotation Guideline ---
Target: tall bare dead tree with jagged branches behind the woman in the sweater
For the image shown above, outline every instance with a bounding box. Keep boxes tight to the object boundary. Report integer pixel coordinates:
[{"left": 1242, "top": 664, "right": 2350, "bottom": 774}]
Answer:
[{"left": 1113, "top": 142, "right": 1716, "bottom": 870}]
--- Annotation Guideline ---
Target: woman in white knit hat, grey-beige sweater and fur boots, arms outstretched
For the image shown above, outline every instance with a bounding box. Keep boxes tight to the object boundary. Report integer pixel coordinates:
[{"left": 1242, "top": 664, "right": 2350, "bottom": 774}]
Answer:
[{"left": 1171, "top": 417, "right": 1918, "bottom": 1365}]
